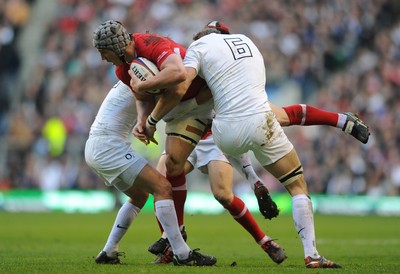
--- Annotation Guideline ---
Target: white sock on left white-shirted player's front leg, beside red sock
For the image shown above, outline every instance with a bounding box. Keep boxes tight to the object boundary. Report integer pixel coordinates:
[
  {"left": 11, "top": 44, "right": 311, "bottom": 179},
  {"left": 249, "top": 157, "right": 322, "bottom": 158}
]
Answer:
[{"left": 154, "top": 200, "right": 190, "bottom": 260}]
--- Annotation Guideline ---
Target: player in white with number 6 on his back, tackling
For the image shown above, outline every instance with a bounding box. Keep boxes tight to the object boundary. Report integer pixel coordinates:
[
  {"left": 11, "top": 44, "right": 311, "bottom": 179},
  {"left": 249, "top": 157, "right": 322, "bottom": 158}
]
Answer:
[{"left": 141, "top": 25, "right": 341, "bottom": 268}]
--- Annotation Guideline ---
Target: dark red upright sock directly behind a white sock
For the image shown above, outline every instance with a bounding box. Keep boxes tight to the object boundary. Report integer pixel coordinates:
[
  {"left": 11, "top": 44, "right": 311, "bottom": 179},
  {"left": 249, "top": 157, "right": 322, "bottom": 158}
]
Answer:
[{"left": 167, "top": 172, "right": 187, "bottom": 226}]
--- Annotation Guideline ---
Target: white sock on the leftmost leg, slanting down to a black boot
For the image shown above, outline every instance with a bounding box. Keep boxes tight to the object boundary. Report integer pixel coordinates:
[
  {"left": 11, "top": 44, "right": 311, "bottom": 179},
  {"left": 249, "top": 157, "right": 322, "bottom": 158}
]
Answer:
[{"left": 103, "top": 202, "right": 140, "bottom": 256}]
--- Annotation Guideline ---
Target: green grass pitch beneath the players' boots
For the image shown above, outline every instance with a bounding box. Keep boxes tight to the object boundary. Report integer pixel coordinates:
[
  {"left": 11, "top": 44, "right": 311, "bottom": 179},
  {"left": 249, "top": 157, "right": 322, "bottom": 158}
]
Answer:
[{"left": 0, "top": 212, "right": 400, "bottom": 274}]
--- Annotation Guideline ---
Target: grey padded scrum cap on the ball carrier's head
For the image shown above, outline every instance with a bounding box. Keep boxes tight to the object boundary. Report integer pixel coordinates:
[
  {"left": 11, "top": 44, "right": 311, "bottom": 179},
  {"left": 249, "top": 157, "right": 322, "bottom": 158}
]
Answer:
[{"left": 93, "top": 20, "right": 131, "bottom": 56}]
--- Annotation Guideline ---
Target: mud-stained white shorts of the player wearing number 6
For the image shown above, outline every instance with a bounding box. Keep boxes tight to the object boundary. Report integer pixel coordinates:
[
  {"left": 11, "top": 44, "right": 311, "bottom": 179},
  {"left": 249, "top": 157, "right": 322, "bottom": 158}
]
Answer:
[{"left": 212, "top": 111, "right": 293, "bottom": 166}]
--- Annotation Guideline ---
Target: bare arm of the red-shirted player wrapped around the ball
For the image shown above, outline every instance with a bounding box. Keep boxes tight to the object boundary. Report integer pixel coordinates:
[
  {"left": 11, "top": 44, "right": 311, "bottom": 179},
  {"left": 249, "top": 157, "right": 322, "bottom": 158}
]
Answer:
[{"left": 129, "top": 54, "right": 186, "bottom": 94}]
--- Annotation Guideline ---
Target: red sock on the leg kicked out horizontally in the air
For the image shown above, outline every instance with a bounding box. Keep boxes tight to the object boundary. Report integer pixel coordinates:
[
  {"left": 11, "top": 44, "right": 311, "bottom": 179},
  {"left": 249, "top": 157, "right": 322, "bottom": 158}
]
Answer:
[{"left": 283, "top": 104, "right": 339, "bottom": 127}]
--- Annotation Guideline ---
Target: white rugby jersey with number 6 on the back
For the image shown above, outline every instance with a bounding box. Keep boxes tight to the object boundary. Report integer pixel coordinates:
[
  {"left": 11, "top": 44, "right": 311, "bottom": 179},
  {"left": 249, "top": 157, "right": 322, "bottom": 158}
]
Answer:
[{"left": 184, "top": 33, "right": 271, "bottom": 118}]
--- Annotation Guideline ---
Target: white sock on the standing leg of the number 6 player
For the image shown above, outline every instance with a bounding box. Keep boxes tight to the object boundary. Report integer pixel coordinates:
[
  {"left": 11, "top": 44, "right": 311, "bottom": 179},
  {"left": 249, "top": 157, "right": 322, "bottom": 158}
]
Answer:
[{"left": 292, "top": 194, "right": 319, "bottom": 258}]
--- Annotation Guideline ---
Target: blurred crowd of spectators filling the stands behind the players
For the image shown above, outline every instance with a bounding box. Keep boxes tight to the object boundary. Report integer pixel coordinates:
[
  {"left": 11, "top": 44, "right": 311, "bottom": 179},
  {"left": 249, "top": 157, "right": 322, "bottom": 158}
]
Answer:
[{"left": 0, "top": 0, "right": 400, "bottom": 196}]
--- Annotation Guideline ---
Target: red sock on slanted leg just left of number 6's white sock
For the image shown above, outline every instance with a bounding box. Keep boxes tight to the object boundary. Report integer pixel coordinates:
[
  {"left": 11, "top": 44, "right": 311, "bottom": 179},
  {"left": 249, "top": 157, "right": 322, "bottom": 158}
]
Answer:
[{"left": 225, "top": 196, "right": 265, "bottom": 242}]
